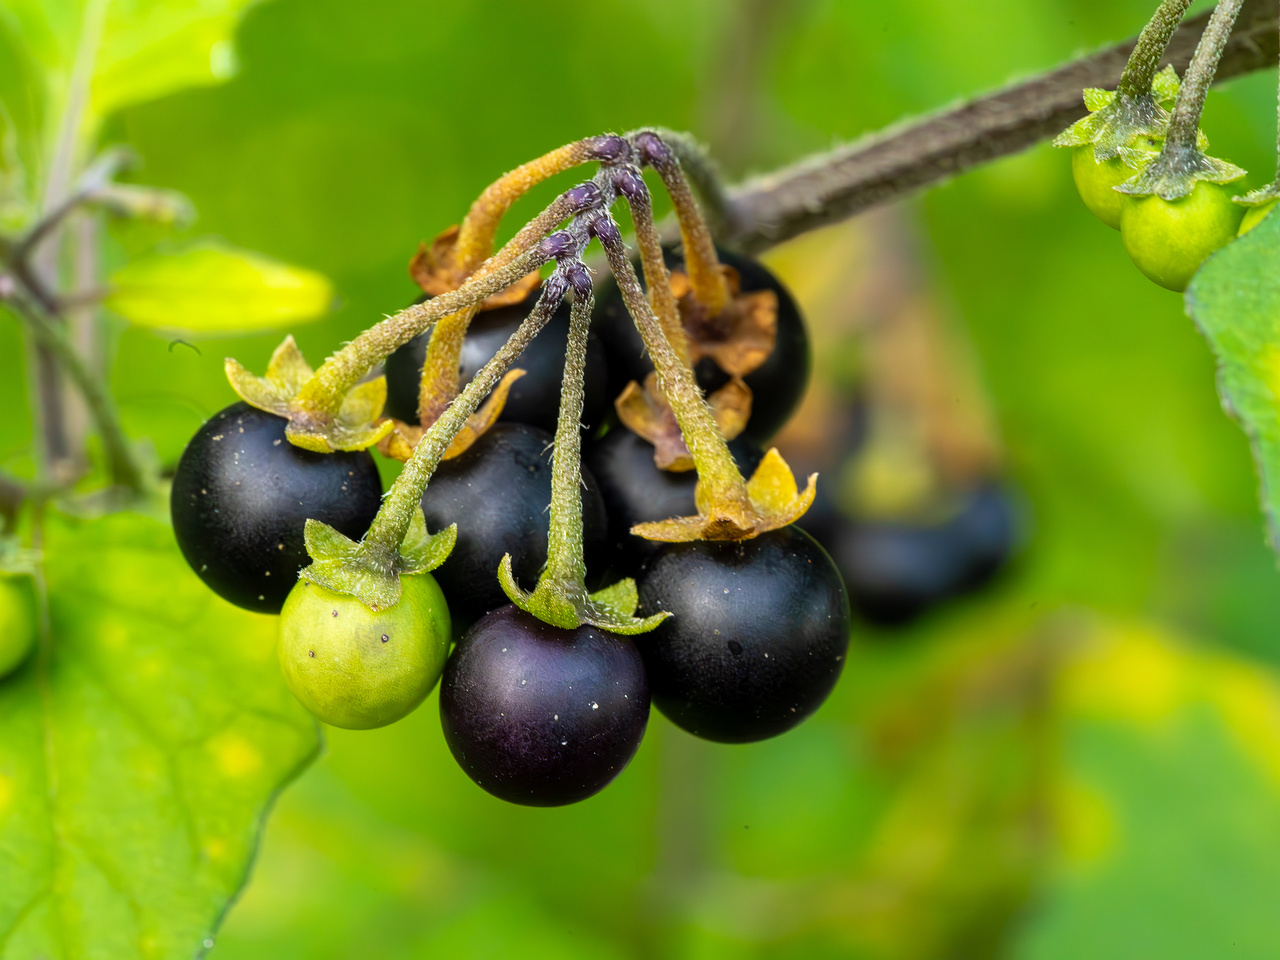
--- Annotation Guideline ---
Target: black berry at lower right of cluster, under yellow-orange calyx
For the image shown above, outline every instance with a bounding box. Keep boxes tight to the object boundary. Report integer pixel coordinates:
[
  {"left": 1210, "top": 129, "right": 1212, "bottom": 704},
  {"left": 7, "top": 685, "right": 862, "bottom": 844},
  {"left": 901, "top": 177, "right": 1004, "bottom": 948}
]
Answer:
[{"left": 636, "top": 526, "right": 850, "bottom": 744}]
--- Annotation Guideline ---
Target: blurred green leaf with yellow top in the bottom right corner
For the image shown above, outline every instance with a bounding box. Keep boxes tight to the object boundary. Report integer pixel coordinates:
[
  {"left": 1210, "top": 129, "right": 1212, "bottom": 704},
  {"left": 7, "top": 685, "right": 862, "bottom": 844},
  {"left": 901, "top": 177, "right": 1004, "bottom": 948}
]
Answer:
[{"left": 1014, "top": 625, "right": 1280, "bottom": 960}]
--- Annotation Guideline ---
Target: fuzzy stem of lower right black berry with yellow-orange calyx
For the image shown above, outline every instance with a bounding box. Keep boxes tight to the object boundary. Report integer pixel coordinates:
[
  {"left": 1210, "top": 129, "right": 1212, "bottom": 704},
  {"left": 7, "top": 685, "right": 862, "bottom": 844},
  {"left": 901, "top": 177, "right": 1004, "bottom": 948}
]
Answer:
[{"left": 596, "top": 220, "right": 750, "bottom": 511}]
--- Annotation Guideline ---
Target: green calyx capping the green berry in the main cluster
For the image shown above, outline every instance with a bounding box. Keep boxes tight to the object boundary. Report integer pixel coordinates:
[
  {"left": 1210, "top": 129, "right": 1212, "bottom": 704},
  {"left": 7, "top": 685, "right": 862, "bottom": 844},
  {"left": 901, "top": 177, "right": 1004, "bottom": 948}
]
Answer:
[{"left": 300, "top": 507, "right": 458, "bottom": 611}]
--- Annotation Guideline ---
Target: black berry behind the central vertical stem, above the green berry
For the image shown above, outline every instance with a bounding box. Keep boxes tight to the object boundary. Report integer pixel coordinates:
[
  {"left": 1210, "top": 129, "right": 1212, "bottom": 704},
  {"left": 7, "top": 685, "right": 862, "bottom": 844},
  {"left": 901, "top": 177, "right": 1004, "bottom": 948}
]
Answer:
[{"left": 422, "top": 424, "right": 608, "bottom": 631}]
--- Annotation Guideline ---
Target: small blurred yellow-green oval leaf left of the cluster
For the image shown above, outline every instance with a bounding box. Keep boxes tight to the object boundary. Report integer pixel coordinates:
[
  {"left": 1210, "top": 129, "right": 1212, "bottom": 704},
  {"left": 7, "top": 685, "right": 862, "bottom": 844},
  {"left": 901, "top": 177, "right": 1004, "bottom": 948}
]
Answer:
[{"left": 105, "top": 242, "right": 333, "bottom": 333}]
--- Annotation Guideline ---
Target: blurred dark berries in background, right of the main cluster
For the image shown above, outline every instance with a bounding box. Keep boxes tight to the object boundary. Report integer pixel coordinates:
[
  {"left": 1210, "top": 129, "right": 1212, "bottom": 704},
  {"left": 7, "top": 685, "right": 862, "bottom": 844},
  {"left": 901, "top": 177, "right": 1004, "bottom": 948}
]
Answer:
[{"left": 800, "top": 484, "right": 1018, "bottom": 626}]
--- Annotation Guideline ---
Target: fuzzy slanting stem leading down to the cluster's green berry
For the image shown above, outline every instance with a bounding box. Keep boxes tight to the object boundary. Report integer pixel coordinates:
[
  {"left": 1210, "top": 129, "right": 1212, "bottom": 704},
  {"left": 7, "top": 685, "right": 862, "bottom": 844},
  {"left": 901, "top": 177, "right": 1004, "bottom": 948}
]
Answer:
[{"left": 361, "top": 282, "right": 563, "bottom": 556}]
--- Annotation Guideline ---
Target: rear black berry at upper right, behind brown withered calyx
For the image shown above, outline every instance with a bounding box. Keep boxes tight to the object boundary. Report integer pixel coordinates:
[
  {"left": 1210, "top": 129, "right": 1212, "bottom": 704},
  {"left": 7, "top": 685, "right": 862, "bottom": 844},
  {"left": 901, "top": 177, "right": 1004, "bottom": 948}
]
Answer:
[{"left": 595, "top": 247, "right": 810, "bottom": 444}]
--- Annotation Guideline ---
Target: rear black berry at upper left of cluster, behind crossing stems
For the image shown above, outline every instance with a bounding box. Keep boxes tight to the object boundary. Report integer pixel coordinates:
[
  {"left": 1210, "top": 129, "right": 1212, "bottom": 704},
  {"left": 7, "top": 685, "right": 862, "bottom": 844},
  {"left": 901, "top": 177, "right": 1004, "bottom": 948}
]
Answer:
[{"left": 384, "top": 291, "right": 611, "bottom": 433}]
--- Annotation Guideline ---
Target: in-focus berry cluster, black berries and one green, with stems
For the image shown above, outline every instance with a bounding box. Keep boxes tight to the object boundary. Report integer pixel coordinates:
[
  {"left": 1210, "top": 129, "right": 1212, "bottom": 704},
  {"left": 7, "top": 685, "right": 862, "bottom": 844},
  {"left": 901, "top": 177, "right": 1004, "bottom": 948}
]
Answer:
[{"left": 172, "top": 131, "right": 1008, "bottom": 805}]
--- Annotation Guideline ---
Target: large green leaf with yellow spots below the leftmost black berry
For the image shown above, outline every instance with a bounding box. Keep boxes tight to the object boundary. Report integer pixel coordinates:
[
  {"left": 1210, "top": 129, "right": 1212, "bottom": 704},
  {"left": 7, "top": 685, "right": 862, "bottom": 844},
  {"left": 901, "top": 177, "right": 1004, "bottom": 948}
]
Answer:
[{"left": 0, "top": 515, "right": 317, "bottom": 960}]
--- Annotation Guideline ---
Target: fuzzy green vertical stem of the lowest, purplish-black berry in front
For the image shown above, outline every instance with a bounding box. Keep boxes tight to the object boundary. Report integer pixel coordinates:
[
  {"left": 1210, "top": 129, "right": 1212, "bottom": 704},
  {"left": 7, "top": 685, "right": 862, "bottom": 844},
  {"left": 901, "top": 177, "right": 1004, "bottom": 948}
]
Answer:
[{"left": 539, "top": 296, "right": 595, "bottom": 595}]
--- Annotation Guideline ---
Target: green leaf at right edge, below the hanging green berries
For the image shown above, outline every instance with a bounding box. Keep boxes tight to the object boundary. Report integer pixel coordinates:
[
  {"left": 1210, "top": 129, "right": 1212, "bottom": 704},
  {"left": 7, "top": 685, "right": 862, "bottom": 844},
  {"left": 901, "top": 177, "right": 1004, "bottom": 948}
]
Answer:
[{"left": 1187, "top": 216, "right": 1280, "bottom": 549}]
